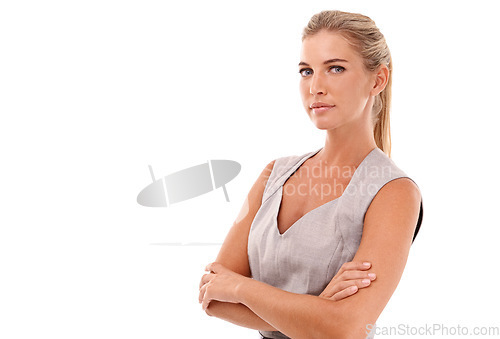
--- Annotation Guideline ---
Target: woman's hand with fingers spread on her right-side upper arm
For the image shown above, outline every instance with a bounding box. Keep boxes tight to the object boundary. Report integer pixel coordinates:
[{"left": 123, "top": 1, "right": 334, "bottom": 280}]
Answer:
[{"left": 319, "top": 261, "right": 376, "bottom": 301}]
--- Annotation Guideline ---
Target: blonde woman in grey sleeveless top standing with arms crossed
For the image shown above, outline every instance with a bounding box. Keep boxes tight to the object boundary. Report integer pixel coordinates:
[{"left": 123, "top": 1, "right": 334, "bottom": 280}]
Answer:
[{"left": 200, "top": 11, "right": 423, "bottom": 338}]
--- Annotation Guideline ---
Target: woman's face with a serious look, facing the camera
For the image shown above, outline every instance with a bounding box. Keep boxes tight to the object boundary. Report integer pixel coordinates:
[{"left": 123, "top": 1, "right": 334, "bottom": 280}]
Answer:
[{"left": 299, "top": 30, "right": 378, "bottom": 130}]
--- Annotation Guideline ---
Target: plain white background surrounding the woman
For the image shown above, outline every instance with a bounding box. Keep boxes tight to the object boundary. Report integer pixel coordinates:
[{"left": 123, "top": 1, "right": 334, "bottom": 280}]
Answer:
[{"left": 0, "top": 0, "right": 500, "bottom": 339}]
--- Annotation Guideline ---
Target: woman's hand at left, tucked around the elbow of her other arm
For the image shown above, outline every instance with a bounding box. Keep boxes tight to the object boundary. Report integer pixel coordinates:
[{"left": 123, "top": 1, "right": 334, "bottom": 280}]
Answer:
[{"left": 199, "top": 262, "right": 248, "bottom": 310}]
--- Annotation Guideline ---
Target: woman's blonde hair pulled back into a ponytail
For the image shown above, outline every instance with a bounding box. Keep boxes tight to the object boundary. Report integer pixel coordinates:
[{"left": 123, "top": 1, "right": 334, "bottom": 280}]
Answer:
[{"left": 302, "top": 11, "right": 392, "bottom": 157}]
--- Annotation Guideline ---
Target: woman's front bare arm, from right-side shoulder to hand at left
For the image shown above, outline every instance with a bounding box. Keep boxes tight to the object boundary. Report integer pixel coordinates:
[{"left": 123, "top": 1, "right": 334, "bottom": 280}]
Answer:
[{"left": 203, "top": 178, "right": 421, "bottom": 338}]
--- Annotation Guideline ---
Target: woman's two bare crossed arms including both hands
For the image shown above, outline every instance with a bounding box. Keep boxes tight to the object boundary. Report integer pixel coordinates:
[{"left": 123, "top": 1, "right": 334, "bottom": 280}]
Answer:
[{"left": 200, "top": 162, "right": 421, "bottom": 338}]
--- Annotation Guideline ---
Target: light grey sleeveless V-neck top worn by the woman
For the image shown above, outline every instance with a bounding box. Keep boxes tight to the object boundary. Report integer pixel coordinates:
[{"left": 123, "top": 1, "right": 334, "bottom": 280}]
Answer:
[{"left": 248, "top": 147, "right": 423, "bottom": 339}]
